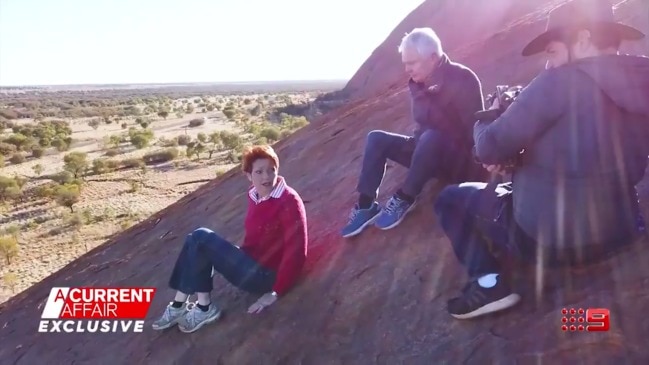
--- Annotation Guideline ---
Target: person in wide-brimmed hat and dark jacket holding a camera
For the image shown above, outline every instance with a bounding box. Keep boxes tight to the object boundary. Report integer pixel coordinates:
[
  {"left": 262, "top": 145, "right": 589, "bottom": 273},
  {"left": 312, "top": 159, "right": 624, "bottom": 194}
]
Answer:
[{"left": 435, "top": 0, "right": 649, "bottom": 319}]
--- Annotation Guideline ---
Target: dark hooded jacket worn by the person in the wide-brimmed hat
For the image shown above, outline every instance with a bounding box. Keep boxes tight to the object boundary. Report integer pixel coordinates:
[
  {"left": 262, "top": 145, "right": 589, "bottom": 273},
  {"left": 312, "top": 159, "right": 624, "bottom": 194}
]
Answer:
[{"left": 474, "top": 55, "right": 649, "bottom": 247}]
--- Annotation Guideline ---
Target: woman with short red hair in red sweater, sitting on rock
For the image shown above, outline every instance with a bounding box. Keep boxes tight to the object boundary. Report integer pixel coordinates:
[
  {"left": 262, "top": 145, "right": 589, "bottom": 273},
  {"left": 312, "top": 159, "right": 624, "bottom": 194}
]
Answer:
[{"left": 153, "top": 146, "right": 307, "bottom": 332}]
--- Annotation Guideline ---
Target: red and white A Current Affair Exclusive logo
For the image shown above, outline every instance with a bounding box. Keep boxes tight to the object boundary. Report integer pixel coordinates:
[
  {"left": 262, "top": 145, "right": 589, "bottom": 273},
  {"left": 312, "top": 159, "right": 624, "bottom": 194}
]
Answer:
[{"left": 38, "top": 287, "right": 156, "bottom": 333}]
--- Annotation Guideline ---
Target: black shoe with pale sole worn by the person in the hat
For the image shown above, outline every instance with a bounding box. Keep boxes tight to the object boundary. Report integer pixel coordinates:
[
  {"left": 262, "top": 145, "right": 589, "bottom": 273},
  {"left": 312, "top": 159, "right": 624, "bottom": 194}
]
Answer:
[{"left": 447, "top": 278, "right": 521, "bottom": 319}]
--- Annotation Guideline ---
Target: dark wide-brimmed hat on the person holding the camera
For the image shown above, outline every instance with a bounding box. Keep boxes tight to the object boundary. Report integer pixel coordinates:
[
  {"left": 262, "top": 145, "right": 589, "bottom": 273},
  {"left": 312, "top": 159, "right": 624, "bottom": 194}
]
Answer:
[{"left": 523, "top": 0, "right": 645, "bottom": 56}]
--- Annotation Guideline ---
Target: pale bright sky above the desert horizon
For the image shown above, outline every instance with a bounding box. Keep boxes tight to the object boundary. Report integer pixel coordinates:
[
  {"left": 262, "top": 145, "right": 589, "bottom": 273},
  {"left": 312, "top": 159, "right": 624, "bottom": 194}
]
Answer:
[{"left": 0, "top": 0, "right": 423, "bottom": 86}]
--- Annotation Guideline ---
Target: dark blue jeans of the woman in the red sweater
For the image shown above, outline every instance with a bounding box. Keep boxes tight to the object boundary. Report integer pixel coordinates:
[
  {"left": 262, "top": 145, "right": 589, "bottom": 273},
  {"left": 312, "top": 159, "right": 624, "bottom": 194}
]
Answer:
[{"left": 169, "top": 228, "right": 275, "bottom": 295}]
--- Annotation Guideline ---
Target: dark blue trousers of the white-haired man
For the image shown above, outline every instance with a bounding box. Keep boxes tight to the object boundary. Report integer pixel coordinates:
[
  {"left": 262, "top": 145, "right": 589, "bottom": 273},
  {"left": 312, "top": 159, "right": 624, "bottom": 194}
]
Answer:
[{"left": 357, "top": 129, "right": 476, "bottom": 199}]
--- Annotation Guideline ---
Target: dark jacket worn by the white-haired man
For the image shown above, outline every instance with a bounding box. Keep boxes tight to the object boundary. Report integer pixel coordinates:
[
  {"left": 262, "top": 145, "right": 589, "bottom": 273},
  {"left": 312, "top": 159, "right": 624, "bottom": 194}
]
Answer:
[{"left": 408, "top": 55, "right": 484, "bottom": 149}]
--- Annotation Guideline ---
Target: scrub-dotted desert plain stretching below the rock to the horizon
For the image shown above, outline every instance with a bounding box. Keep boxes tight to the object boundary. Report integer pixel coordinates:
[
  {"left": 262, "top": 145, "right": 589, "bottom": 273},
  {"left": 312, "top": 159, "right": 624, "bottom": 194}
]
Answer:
[{"left": 0, "top": 83, "right": 344, "bottom": 303}]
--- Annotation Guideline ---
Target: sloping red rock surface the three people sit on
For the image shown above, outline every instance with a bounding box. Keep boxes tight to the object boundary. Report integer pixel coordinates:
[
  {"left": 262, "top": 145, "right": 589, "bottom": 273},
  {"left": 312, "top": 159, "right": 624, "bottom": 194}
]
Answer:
[{"left": 0, "top": 0, "right": 649, "bottom": 365}]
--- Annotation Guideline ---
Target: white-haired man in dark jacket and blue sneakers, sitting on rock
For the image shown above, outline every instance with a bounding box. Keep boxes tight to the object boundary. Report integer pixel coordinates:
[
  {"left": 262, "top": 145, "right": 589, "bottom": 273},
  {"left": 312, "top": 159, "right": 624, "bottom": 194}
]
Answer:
[{"left": 341, "top": 28, "right": 486, "bottom": 237}]
